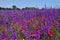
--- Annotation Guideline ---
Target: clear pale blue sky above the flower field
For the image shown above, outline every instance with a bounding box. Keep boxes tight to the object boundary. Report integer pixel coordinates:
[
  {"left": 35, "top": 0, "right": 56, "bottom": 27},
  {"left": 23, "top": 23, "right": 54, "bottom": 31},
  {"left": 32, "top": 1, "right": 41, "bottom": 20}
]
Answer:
[{"left": 0, "top": 0, "right": 60, "bottom": 8}]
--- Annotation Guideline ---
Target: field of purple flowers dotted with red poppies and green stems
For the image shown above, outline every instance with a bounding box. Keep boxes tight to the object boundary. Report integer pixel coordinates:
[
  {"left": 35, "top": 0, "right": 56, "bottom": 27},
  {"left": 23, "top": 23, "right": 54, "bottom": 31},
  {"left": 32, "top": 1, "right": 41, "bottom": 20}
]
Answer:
[{"left": 0, "top": 9, "right": 60, "bottom": 40}]
